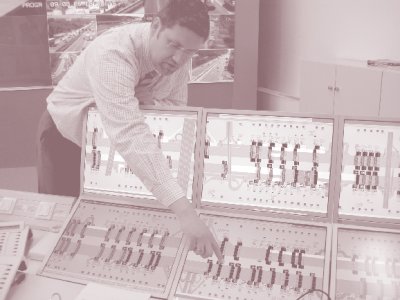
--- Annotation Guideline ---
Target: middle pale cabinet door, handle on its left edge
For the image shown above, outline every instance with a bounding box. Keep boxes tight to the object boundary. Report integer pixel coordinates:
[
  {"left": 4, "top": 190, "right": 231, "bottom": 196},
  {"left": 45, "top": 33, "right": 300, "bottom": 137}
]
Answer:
[{"left": 334, "top": 65, "right": 382, "bottom": 116}]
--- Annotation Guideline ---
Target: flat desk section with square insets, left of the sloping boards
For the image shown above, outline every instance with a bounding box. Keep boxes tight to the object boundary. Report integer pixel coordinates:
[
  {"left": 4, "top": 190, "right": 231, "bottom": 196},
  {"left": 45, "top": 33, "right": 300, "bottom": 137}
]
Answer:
[{"left": 0, "top": 190, "right": 75, "bottom": 232}]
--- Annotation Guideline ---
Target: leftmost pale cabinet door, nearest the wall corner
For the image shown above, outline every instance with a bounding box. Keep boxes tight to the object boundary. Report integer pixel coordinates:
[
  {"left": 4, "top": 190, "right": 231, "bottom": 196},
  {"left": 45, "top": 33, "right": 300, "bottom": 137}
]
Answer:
[{"left": 300, "top": 61, "right": 335, "bottom": 114}]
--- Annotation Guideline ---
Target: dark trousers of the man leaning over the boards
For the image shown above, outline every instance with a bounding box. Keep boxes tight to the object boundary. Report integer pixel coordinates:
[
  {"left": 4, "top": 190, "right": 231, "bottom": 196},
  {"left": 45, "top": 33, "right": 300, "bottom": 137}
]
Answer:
[{"left": 37, "top": 110, "right": 81, "bottom": 197}]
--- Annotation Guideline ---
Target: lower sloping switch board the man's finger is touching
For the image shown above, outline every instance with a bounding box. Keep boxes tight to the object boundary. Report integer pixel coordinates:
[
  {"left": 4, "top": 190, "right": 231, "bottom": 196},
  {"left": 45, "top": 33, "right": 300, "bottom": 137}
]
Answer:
[{"left": 176, "top": 215, "right": 330, "bottom": 300}]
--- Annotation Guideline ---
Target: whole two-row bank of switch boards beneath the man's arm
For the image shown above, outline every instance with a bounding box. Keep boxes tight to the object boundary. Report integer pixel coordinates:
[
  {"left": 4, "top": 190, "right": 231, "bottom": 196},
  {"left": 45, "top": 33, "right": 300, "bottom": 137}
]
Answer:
[{"left": 27, "top": 109, "right": 400, "bottom": 300}]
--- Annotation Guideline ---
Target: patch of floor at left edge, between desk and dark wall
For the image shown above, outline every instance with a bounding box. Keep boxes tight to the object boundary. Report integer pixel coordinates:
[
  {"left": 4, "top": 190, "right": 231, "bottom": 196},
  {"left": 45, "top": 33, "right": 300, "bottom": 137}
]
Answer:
[{"left": 0, "top": 166, "right": 37, "bottom": 192}]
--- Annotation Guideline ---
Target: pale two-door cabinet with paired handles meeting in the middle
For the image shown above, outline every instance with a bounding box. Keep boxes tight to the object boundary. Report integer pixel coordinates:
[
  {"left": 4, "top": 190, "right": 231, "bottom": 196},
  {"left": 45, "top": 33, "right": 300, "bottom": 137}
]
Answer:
[{"left": 300, "top": 61, "right": 383, "bottom": 116}]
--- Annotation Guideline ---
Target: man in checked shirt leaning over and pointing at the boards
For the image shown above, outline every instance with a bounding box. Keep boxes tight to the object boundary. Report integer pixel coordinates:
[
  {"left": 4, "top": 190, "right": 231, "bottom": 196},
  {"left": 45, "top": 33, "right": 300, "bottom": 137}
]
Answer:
[{"left": 38, "top": 0, "right": 222, "bottom": 259}]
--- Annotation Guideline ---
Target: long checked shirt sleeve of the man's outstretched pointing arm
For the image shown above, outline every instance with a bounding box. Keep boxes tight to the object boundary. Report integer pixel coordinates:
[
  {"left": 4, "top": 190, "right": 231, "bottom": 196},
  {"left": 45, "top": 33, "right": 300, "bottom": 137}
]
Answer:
[{"left": 85, "top": 42, "right": 185, "bottom": 206}]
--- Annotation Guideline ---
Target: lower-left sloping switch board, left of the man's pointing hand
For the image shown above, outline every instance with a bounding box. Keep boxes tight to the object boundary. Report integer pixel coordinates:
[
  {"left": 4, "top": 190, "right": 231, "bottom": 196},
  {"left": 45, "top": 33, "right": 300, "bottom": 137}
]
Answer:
[{"left": 41, "top": 199, "right": 184, "bottom": 297}]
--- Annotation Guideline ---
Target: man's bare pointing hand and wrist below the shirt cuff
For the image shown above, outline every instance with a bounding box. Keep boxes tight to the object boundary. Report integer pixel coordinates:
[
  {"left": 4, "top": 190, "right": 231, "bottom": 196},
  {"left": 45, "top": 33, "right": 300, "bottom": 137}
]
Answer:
[{"left": 170, "top": 198, "right": 223, "bottom": 261}]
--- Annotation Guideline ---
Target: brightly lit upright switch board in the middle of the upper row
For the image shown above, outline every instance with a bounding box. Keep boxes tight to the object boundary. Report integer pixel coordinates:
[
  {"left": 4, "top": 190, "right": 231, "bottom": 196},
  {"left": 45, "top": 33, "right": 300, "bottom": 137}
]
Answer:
[{"left": 202, "top": 113, "right": 334, "bottom": 214}]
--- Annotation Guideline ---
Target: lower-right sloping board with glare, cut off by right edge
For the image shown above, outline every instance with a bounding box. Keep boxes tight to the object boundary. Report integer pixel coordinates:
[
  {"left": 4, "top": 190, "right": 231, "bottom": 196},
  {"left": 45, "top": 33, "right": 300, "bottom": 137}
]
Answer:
[{"left": 331, "top": 228, "right": 400, "bottom": 300}]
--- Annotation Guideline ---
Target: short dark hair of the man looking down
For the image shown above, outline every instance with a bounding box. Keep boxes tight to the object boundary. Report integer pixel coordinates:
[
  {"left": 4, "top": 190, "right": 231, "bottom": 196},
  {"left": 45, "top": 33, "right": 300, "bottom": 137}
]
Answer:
[{"left": 158, "top": 0, "right": 210, "bottom": 40}]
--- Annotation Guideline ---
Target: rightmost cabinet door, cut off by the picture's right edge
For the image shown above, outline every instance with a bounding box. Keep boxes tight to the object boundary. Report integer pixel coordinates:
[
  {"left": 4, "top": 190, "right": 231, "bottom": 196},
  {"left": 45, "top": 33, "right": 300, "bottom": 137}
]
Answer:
[{"left": 379, "top": 71, "right": 400, "bottom": 118}]
